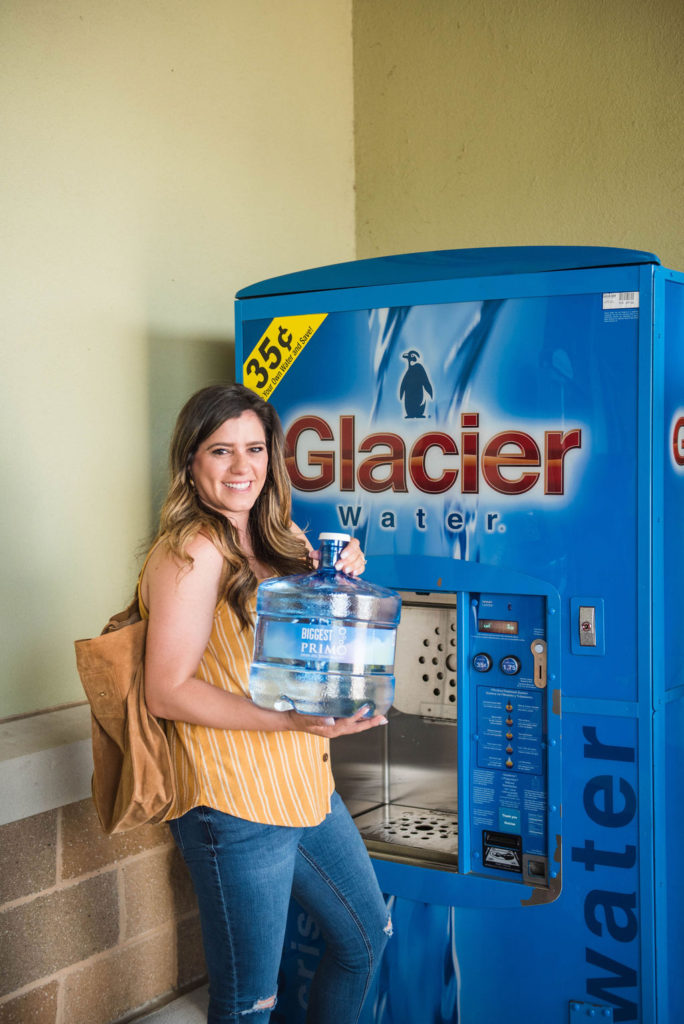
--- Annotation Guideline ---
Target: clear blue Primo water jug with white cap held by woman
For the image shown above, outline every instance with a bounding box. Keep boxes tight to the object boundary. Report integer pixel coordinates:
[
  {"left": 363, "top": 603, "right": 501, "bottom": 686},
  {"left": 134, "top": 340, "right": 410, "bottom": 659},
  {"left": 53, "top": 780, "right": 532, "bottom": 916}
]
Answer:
[{"left": 250, "top": 534, "right": 401, "bottom": 718}]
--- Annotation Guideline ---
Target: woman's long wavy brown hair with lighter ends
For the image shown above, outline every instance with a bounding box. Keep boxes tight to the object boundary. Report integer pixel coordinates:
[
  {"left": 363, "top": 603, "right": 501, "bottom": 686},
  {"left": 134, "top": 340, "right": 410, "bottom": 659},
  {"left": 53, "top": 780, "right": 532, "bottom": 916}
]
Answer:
[{"left": 158, "top": 384, "right": 307, "bottom": 627}]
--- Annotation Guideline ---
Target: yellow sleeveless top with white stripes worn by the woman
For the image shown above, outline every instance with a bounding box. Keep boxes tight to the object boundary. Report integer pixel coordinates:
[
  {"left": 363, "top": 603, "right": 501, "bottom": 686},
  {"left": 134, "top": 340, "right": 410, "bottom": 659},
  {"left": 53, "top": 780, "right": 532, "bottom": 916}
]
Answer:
[{"left": 138, "top": 548, "right": 333, "bottom": 826}]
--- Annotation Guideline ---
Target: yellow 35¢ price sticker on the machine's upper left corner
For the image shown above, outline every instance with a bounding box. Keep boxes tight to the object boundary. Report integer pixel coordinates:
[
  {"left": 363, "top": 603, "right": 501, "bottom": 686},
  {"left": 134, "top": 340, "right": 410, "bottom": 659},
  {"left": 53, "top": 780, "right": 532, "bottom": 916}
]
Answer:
[{"left": 243, "top": 313, "right": 328, "bottom": 400}]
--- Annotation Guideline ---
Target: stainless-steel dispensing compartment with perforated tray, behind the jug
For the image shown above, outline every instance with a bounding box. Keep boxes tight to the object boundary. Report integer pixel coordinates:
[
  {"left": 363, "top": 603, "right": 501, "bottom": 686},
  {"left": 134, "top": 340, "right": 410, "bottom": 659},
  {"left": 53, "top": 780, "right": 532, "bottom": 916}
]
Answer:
[{"left": 333, "top": 591, "right": 459, "bottom": 870}]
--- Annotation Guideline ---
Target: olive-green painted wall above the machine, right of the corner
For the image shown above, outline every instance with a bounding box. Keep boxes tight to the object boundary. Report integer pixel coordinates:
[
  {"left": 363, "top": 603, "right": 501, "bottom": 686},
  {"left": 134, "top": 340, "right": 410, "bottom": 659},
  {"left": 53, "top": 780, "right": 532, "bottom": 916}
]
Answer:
[{"left": 354, "top": 0, "right": 684, "bottom": 269}]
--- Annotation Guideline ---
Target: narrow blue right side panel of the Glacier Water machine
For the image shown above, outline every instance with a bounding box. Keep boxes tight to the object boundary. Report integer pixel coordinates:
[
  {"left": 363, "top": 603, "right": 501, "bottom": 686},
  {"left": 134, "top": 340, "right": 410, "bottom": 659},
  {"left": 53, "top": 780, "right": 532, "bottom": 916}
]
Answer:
[{"left": 653, "top": 270, "right": 684, "bottom": 1022}]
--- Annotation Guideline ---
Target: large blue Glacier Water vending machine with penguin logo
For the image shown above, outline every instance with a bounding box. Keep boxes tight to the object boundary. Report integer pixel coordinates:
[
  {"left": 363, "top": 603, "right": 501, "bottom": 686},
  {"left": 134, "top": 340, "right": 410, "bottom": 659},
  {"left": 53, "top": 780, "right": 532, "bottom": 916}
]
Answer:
[{"left": 237, "top": 247, "right": 684, "bottom": 1024}]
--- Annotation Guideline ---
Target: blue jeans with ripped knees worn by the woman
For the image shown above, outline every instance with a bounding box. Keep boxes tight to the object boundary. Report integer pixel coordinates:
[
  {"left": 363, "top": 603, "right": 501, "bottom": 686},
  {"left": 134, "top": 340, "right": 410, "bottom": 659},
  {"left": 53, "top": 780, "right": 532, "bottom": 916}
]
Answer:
[{"left": 170, "top": 793, "right": 391, "bottom": 1024}]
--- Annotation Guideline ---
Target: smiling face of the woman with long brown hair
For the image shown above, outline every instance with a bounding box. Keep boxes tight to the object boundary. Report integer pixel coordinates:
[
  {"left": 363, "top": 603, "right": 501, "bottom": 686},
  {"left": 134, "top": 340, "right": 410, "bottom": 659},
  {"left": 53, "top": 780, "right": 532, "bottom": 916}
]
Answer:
[{"left": 191, "top": 411, "right": 268, "bottom": 529}]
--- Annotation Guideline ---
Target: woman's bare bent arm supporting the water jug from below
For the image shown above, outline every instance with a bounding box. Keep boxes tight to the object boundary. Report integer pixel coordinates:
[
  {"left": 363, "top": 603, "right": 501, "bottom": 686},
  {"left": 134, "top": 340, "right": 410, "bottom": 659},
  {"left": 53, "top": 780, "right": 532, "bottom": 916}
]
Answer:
[{"left": 143, "top": 536, "right": 384, "bottom": 738}]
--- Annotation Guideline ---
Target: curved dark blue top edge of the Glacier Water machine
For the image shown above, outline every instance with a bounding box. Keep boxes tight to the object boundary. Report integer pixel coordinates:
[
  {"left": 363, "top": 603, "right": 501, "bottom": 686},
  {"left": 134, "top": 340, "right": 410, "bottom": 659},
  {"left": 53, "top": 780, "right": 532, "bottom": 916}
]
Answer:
[{"left": 237, "top": 246, "right": 660, "bottom": 299}]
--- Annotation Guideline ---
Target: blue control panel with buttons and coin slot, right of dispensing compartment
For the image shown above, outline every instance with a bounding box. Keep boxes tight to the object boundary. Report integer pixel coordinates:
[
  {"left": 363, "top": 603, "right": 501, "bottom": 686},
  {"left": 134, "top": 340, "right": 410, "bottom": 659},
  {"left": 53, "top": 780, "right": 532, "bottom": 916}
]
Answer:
[{"left": 468, "top": 594, "right": 548, "bottom": 886}]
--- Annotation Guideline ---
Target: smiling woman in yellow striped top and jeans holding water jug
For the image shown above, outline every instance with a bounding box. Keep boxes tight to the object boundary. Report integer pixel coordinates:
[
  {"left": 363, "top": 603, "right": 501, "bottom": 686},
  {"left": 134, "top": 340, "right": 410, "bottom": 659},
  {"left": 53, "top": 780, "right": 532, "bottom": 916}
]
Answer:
[{"left": 139, "top": 384, "right": 390, "bottom": 1024}]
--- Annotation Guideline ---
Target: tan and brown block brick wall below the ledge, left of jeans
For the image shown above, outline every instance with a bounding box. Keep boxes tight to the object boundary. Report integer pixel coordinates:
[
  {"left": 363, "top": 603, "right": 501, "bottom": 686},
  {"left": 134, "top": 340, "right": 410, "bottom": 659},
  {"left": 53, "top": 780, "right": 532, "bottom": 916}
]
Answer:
[{"left": 0, "top": 800, "right": 206, "bottom": 1024}]
